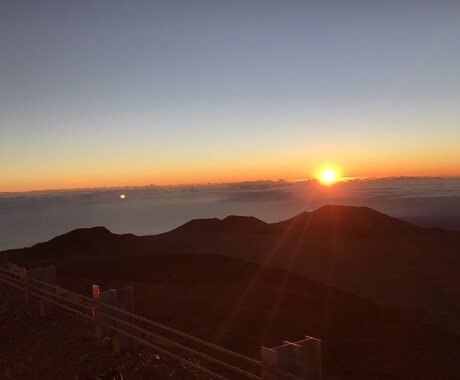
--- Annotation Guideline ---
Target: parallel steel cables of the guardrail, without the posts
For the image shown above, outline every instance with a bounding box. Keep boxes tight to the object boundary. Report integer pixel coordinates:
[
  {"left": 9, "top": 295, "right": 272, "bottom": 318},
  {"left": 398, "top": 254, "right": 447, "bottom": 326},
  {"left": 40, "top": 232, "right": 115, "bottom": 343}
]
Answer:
[{"left": 0, "top": 267, "right": 302, "bottom": 380}]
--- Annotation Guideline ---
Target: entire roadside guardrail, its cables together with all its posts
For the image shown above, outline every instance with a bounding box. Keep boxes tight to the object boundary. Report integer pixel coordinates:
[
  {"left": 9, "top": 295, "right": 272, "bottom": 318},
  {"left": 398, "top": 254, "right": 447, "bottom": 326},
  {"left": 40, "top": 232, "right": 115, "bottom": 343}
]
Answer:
[{"left": 0, "top": 257, "right": 321, "bottom": 380}]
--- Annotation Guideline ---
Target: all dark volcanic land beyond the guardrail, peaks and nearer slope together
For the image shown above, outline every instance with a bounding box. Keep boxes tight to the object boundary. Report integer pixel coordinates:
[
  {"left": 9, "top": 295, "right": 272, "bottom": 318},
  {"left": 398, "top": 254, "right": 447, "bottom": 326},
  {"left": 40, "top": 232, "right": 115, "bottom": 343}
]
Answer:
[{"left": 2, "top": 206, "right": 460, "bottom": 379}]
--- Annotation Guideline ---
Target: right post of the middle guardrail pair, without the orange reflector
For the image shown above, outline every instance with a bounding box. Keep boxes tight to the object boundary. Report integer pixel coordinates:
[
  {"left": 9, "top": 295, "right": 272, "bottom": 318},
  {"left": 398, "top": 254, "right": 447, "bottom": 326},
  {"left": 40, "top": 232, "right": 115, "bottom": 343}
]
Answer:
[{"left": 113, "top": 286, "right": 134, "bottom": 353}]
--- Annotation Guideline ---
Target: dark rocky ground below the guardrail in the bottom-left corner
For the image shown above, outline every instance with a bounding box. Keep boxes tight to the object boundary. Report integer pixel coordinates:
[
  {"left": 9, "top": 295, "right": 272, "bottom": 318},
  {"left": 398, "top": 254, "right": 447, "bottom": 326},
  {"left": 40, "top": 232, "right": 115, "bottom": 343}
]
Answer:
[{"left": 0, "top": 284, "right": 210, "bottom": 380}]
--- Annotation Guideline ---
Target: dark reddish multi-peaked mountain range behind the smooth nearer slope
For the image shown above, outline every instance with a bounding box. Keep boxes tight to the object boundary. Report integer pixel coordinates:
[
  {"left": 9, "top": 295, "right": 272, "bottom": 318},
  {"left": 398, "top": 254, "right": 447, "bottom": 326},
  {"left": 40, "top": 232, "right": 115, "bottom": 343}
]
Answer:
[{"left": 3, "top": 206, "right": 460, "bottom": 335}]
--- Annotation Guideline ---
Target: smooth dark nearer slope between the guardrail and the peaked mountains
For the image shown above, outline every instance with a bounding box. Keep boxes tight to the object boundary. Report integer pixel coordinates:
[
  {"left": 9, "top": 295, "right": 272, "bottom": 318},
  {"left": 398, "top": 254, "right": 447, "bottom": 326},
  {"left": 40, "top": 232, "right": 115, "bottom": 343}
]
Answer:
[{"left": 30, "top": 254, "right": 460, "bottom": 380}]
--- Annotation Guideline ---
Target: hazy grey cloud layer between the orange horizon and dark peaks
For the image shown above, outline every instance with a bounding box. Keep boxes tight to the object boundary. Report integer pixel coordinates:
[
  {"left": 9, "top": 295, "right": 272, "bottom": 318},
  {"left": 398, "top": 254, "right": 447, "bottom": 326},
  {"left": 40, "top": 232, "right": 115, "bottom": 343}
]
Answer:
[{"left": 0, "top": 178, "right": 460, "bottom": 250}]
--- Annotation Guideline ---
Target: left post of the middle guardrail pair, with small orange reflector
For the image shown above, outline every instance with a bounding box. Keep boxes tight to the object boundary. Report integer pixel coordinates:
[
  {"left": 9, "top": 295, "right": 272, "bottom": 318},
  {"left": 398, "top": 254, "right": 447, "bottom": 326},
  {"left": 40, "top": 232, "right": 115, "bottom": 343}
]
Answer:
[{"left": 93, "top": 285, "right": 117, "bottom": 339}]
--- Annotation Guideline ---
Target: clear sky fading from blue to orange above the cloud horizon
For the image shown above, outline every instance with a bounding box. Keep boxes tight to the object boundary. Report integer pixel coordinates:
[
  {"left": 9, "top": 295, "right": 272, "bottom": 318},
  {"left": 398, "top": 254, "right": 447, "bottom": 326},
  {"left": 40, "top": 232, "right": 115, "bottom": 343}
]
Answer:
[{"left": 0, "top": 0, "right": 460, "bottom": 191}]
